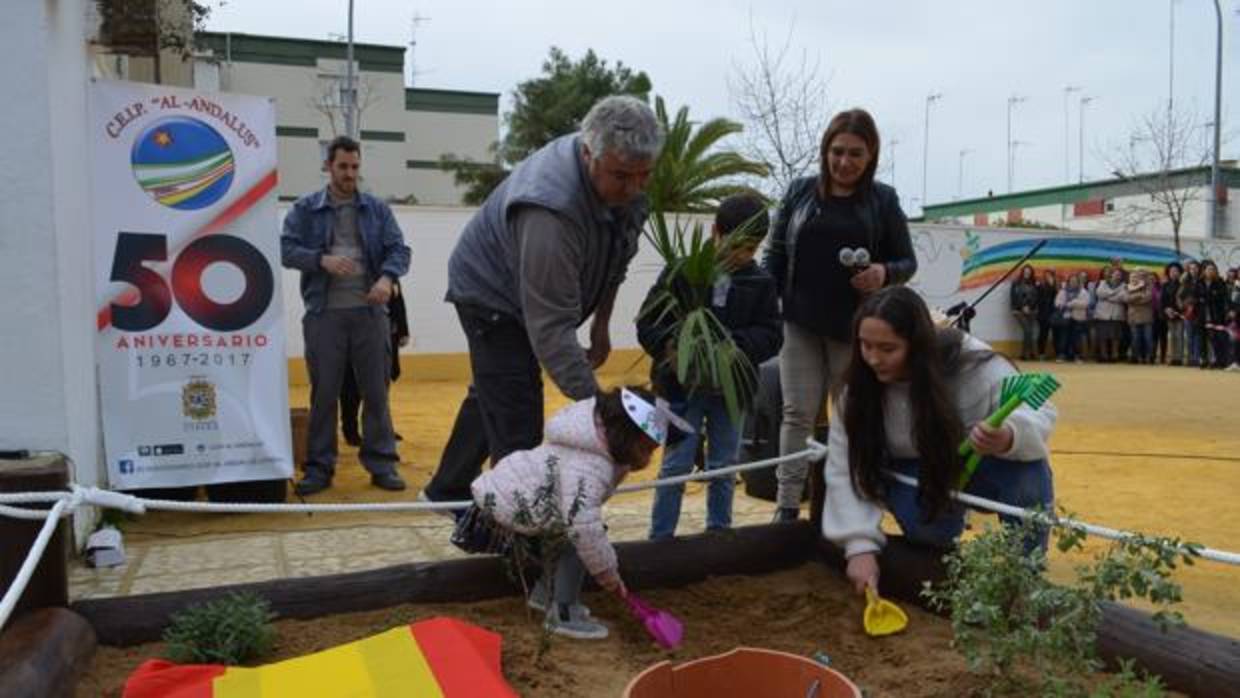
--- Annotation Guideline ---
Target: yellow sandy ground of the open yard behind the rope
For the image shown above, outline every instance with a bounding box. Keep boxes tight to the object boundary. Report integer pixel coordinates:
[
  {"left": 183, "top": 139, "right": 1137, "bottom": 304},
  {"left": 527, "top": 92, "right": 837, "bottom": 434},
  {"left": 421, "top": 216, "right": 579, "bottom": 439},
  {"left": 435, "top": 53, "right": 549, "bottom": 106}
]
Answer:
[{"left": 118, "top": 362, "right": 1240, "bottom": 637}]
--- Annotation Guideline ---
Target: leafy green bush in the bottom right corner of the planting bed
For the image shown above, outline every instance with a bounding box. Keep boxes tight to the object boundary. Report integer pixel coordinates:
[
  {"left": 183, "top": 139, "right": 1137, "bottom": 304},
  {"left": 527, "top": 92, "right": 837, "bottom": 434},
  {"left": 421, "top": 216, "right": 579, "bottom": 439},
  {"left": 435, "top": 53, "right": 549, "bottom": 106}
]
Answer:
[{"left": 923, "top": 517, "right": 1199, "bottom": 698}]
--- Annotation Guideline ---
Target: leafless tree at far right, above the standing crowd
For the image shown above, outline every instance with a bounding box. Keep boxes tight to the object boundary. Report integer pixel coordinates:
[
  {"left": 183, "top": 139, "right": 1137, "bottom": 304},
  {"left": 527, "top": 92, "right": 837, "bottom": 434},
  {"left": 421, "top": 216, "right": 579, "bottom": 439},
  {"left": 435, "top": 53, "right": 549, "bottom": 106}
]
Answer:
[{"left": 1105, "top": 105, "right": 1210, "bottom": 253}]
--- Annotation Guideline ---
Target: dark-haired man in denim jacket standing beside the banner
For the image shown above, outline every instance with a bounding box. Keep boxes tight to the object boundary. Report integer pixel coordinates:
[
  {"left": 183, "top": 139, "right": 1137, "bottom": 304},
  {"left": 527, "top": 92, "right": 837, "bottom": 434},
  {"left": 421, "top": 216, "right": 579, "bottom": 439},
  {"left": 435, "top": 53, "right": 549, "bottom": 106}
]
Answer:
[{"left": 280, "top": 136, "right": 409, "bottom": 495}]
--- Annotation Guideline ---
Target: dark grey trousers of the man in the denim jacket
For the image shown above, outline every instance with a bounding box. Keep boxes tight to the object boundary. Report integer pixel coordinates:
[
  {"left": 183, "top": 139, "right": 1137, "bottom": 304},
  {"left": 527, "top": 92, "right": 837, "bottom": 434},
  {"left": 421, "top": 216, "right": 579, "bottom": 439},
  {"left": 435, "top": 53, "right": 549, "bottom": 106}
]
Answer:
[{"left": 301, "top": 305, "right": 399, "bottom": 481}]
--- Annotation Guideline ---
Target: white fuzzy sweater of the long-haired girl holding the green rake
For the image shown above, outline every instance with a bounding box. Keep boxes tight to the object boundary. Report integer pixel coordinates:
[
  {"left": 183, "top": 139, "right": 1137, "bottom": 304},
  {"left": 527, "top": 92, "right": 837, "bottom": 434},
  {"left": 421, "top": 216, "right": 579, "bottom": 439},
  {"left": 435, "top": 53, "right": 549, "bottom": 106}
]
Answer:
[{"left": 822, "top": 335, "right": 1056, "bottom": 557}]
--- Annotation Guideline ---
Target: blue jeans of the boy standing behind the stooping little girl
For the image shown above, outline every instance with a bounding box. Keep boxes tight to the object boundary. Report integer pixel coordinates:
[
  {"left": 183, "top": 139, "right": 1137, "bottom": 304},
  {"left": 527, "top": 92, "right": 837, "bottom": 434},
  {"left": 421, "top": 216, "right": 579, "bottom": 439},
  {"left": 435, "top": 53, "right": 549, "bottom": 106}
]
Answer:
[{"left": 650, "top": 395, "right": 740, "bottom": 539}]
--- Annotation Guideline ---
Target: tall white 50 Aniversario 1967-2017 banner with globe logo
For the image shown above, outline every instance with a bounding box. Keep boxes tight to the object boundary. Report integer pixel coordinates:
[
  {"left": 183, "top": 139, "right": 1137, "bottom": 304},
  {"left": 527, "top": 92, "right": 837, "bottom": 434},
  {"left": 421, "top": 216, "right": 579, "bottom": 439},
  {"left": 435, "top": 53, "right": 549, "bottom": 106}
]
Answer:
[{"left": 91, "top": 81, "right": 293, "bottom": 488}]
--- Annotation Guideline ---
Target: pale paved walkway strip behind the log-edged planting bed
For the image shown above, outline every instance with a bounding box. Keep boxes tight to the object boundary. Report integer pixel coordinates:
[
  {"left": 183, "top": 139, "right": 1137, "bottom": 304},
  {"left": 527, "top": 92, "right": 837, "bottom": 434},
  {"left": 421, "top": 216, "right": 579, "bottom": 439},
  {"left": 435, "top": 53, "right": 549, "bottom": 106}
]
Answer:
[{"left": 69, "top": 482, "right": 774, "bottom": 599}]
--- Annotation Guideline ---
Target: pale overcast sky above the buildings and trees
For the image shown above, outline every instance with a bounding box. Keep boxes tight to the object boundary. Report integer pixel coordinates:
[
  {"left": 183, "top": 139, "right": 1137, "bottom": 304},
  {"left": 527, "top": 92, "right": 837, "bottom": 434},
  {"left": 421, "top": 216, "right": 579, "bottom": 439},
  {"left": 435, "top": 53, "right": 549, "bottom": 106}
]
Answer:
[{"left": 208, "top": 0, "right": 1240, "bottom": 212}]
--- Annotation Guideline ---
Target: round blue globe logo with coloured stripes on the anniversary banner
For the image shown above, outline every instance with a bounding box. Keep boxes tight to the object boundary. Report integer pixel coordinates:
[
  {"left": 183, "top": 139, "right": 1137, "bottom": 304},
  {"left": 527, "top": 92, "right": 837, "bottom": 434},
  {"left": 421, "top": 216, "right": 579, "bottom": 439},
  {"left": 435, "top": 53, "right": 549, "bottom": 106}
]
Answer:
[{"left": 130, "top": 117, "right": 236, "bottom": 211}]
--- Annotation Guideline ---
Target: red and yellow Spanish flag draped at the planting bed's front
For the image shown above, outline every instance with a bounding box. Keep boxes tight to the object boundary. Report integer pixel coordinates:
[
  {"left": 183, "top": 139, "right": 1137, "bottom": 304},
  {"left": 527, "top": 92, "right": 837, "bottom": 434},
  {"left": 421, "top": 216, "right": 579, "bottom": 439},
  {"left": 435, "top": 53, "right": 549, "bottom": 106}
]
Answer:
[{"left": 123, "top": 617, "right": 517, "bottom": 698}]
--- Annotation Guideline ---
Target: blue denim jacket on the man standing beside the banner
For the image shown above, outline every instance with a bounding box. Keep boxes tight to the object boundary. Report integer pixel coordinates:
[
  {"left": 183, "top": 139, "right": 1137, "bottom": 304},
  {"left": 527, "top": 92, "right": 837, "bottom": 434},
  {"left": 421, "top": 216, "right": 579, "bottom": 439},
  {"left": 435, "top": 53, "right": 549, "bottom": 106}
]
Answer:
[{"left": 280, "top": 187, "right": 409, "bottom": 314}]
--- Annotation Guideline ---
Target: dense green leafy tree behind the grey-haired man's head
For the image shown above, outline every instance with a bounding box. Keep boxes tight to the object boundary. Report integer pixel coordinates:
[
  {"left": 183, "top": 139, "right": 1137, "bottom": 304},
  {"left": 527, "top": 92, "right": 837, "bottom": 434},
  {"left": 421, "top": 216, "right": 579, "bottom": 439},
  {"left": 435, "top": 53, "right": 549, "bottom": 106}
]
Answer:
[{"left": 440, "top": 46, "right": 650, "bottom": 205}]
